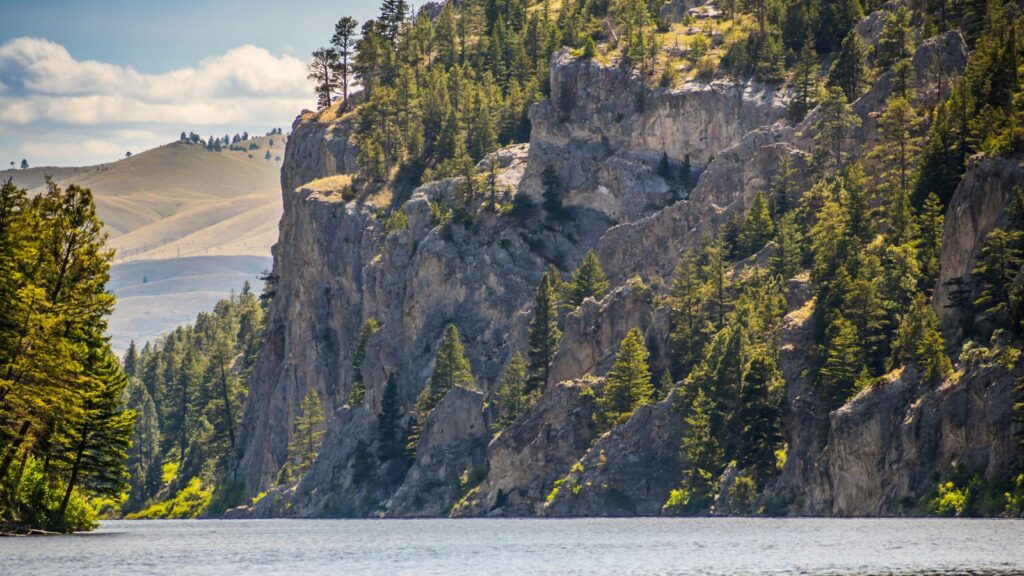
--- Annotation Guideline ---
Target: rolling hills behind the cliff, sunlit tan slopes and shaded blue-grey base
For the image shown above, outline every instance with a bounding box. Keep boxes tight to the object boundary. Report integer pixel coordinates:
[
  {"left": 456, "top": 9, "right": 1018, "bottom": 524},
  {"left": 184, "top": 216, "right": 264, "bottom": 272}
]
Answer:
[{"left": 0, "top": 135, "right": 285, "bottom": 351}]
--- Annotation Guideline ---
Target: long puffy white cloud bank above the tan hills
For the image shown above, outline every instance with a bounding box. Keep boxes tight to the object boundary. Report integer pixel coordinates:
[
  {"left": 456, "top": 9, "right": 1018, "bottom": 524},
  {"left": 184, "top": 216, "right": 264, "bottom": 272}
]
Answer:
[{"left": 0, "top": 37, "right": 312, "bottom": 128}]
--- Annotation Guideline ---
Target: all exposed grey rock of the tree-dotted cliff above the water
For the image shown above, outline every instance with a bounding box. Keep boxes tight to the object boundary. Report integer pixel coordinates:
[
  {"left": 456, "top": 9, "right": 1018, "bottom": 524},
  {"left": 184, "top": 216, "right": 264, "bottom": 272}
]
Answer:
[{"left": 234, "top": 12, "right": 1024, "bottom": 517}]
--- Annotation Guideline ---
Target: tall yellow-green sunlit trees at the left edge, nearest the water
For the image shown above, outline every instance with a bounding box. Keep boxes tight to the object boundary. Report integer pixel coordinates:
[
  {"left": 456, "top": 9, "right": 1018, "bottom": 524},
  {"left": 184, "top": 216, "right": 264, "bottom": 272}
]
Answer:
[{"left": 0, "top": 180, "right": 135, "bottom": 531}]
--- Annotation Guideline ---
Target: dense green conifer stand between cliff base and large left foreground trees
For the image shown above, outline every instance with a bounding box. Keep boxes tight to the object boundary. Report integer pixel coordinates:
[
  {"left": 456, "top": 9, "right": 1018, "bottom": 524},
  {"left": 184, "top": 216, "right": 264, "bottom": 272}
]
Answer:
[{"left": 123, "top": 283, "right": 262, "bottom": 513}]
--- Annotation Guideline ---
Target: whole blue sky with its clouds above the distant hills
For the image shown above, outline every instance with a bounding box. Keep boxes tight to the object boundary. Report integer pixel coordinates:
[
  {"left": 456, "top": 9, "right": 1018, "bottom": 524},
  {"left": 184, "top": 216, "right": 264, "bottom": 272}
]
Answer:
[{"left": 0, "top": 0, "right": 379, "bottom": 169}]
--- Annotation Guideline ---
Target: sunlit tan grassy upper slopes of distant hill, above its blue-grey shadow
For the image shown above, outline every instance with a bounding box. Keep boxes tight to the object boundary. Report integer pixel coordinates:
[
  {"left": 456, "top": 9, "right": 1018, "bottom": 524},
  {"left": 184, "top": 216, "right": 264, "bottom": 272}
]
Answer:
[{"left": 0, "top": 136, "right": 285, "bottom": 262}]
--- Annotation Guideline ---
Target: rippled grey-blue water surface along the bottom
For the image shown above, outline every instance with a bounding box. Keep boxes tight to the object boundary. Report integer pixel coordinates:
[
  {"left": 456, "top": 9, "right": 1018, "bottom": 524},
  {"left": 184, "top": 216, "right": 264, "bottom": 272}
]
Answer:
[{"left": 0, "top": 519, "right": 1024, "bottom": 576}]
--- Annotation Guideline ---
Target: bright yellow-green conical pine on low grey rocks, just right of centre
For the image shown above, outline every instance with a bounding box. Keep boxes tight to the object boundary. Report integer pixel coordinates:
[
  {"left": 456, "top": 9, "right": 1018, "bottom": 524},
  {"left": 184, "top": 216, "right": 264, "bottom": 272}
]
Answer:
[{"left": 598, "top": 328, "right": 654, "bottom": 427}]
